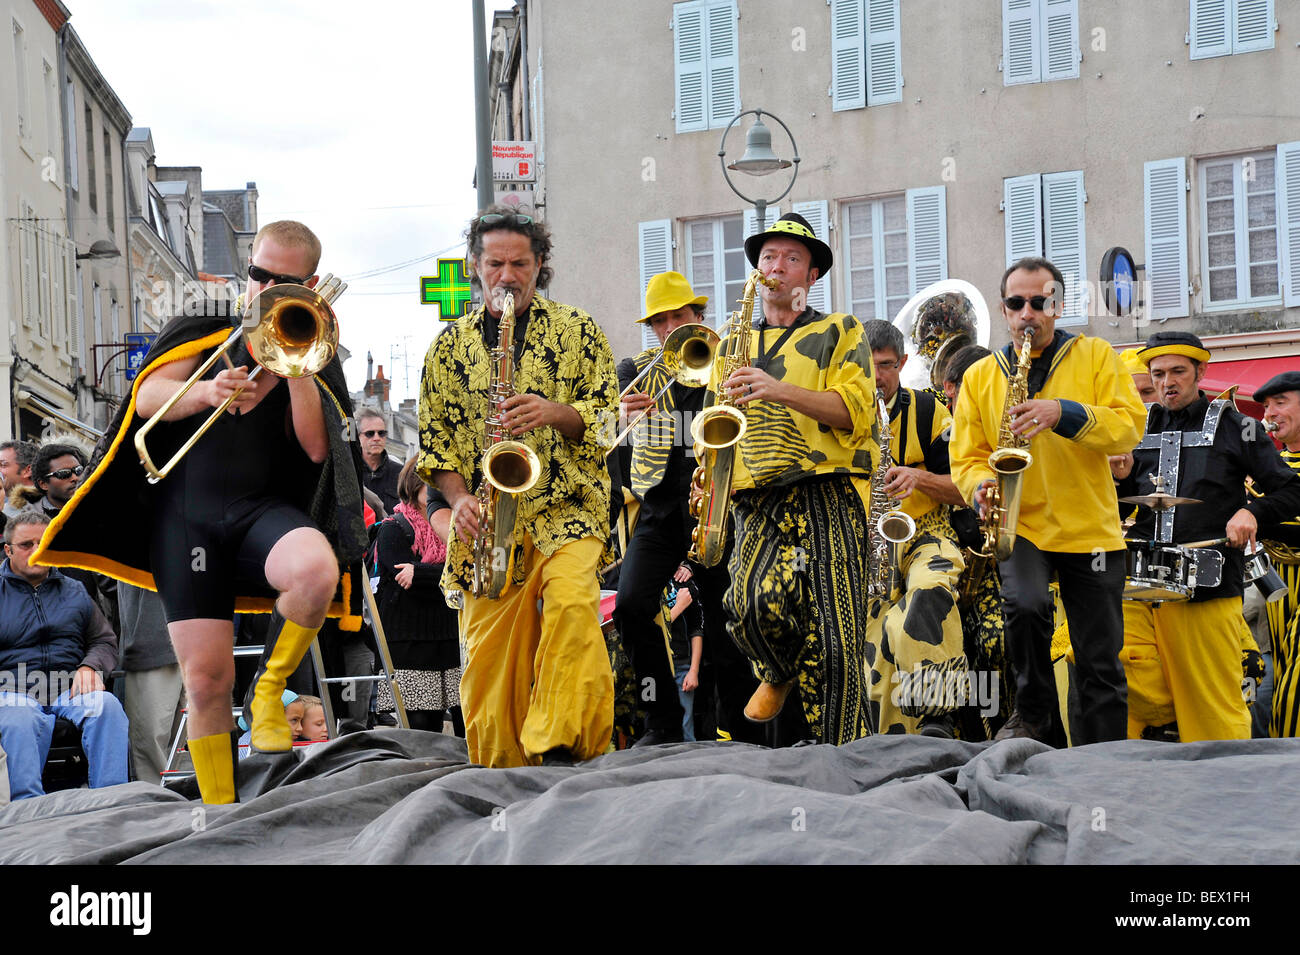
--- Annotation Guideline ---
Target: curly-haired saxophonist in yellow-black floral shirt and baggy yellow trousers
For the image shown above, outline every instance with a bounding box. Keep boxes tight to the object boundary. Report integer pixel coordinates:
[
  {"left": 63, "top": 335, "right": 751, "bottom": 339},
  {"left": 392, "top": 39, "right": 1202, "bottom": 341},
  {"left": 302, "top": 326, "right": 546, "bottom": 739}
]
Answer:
[{"left": 416, "top": 205, "right": 616, "bottom": 767}]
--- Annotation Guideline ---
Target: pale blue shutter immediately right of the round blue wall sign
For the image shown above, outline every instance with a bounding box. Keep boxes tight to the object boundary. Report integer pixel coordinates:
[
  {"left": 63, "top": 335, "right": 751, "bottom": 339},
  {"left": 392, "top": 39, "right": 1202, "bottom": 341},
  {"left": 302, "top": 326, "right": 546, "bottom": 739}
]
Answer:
[{"left": 1143, "top": 157, "right": 1188, "bottom": 318}]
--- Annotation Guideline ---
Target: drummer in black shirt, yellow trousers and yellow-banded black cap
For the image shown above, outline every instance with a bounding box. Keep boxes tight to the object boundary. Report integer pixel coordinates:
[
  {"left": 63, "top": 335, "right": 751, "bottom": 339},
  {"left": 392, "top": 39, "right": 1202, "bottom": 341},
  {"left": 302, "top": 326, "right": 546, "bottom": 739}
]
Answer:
[{"left": 1119, "top": 331, "right": 1300, "bottom": 742}]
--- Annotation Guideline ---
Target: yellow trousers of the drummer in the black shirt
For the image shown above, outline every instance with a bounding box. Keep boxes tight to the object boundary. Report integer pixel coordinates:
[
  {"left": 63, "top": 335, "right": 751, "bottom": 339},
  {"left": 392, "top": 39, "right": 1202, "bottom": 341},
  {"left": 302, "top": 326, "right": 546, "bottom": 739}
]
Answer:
[{"left": 1119, "top": 596, "right": 1253, "bottom": 743}]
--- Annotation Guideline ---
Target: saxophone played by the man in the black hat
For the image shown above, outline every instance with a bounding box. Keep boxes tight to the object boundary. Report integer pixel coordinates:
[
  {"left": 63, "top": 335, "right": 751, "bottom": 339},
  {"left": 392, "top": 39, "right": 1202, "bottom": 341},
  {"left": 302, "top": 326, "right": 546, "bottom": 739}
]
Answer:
[{"left": 686, "top": 269, "right": 779, "bottom": 567}]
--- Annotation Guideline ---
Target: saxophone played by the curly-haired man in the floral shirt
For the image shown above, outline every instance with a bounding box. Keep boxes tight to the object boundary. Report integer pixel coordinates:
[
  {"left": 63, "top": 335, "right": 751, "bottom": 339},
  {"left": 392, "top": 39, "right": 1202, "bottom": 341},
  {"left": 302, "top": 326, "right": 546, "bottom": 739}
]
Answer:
[{"left": 473, "top": 292, "right": 542, "bottom": 600}]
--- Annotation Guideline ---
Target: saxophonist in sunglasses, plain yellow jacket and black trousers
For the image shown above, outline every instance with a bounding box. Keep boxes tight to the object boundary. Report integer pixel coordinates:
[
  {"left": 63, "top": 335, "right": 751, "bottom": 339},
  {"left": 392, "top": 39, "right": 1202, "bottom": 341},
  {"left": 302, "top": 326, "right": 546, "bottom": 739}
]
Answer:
[{"left": 949, "top": 257, "right": 1144, "bottom": 743}]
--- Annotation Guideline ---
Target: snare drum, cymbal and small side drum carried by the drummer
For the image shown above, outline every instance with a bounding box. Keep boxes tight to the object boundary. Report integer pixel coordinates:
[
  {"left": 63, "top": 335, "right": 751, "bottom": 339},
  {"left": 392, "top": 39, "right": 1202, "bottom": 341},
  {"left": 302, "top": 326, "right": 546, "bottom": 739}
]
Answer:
[{"left": 1119, "top": 474, "right": 1287, "bottom": 604}]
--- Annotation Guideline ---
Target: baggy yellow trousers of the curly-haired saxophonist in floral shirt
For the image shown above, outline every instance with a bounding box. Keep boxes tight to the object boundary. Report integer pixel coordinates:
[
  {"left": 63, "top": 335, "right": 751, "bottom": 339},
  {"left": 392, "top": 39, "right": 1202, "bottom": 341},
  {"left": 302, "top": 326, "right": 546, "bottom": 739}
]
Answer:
[{"left": 460, "top": 534, "right": 614, "bottom": 767}]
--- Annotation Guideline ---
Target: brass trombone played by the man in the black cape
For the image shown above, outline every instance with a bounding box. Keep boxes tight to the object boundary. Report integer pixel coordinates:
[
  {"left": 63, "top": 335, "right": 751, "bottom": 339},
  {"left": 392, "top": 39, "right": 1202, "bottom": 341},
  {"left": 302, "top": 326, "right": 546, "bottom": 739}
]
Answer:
[{"left": 135, "top": 275, "right": 347, "bottom": 485}]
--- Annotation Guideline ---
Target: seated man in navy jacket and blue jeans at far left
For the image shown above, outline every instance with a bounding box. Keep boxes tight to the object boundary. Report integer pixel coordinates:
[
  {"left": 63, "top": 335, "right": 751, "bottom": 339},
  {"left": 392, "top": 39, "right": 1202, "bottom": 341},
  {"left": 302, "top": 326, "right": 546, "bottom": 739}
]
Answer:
[{"left": 0, "top": 508, "right": 127, "bottom": 799}]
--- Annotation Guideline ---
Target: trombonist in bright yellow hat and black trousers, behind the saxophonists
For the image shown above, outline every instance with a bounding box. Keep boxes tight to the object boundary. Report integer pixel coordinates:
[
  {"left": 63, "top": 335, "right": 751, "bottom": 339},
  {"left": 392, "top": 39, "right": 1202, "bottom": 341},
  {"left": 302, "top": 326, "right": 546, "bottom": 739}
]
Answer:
[{"left": 614, "top": 272, "right": 763, "bottom": 746}]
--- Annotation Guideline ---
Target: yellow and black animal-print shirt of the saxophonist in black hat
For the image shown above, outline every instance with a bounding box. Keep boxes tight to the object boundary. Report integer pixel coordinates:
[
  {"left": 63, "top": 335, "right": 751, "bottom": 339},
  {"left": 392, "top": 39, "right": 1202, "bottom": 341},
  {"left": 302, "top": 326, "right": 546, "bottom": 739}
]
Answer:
[{"left": 697, "top": 309, "right": 880, "bottom": 490}]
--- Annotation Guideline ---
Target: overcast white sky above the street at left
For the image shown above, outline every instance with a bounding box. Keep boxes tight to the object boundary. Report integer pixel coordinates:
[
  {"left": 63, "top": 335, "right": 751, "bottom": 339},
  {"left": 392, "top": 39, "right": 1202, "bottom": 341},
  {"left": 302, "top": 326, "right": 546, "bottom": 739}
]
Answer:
[{"left": 65, "top": 0, "right": 512, "bottom": 404}]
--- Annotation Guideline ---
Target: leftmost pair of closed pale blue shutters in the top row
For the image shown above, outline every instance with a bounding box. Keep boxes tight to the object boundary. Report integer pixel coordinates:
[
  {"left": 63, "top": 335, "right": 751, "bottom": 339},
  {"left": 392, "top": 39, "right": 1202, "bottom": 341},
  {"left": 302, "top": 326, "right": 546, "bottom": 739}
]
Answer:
[{"left": 672, "top": 0, "right": 740, "bottom": 133}]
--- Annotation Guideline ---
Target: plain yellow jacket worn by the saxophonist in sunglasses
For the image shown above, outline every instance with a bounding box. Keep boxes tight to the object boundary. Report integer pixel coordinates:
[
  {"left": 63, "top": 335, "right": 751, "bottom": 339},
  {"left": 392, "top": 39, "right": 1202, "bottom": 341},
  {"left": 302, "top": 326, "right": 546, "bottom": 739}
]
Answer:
[{"left": 949, "top": 331, "right": 1147, "bottom": 554}]
